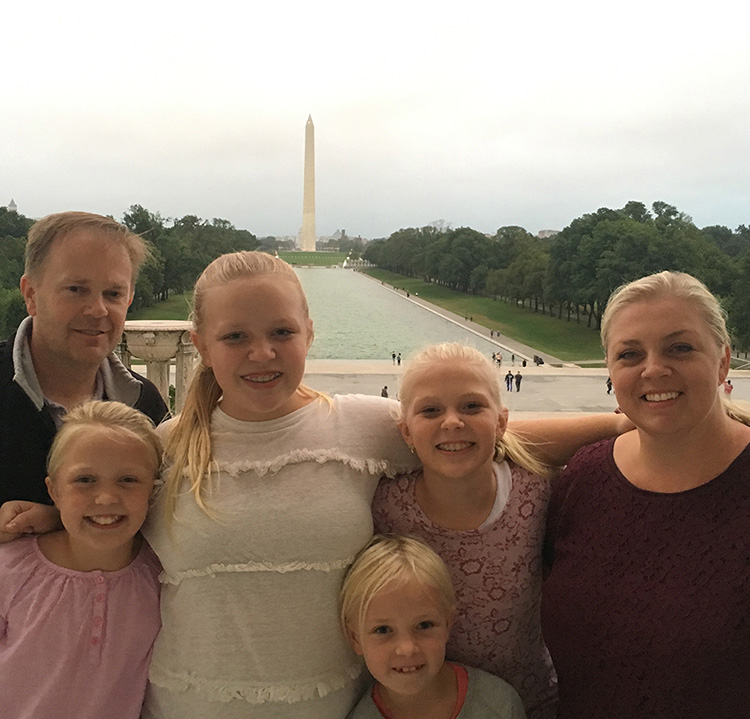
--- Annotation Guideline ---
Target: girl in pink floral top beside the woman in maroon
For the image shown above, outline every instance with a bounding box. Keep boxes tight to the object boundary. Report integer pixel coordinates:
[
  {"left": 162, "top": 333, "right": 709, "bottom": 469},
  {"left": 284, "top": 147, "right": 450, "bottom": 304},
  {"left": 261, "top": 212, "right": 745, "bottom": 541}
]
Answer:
[{"left": 373, "top": 344, "right": 556, "bottom": 719}]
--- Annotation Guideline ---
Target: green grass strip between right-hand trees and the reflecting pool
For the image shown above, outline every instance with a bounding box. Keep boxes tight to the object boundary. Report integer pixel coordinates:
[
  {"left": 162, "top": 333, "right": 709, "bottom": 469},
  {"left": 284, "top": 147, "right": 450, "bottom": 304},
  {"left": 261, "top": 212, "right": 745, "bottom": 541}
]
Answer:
[{"left": 360, "top": 268, "right": 602, "bottom": 361}]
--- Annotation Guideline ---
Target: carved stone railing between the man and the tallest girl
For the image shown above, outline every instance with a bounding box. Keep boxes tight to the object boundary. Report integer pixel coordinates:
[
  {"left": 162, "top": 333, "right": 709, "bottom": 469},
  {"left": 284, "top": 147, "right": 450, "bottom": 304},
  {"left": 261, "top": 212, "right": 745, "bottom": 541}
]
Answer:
[{"left": 115, "top": 320, "right": 198, "bottom": 413}]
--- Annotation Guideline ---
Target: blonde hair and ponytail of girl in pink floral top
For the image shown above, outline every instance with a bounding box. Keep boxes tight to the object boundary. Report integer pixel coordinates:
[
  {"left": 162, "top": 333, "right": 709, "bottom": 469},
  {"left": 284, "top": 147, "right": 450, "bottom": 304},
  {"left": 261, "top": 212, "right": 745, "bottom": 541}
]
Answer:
[{"left": 397, "top": 342, "right": 553, "bottom": 477}]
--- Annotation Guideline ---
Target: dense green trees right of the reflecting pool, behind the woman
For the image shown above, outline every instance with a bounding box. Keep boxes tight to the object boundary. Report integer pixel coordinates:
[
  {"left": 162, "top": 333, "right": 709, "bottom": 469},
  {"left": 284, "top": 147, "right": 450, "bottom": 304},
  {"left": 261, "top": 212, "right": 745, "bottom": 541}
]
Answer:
[{"left": 362, "top": 201, "right": 750, "bottom": 349}]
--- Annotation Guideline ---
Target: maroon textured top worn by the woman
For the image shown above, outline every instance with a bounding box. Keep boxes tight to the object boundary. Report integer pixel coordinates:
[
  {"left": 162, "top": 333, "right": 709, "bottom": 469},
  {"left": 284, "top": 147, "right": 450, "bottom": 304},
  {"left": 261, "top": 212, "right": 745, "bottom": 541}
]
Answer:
[{"left": 542, "top": 440, "right": 750, "bottom": 719}]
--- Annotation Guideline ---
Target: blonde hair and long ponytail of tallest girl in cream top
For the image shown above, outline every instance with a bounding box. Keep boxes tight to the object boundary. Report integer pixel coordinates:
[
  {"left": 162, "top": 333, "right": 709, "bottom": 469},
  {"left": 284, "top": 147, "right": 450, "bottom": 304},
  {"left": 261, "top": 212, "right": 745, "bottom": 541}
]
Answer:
[{"left": 163, "top": 252, "right": 324, "bottom": 523}]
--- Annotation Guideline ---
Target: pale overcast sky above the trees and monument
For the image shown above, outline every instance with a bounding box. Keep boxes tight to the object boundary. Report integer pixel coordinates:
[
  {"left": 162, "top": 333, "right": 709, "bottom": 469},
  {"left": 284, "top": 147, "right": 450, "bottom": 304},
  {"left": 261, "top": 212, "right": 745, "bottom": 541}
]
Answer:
[{"left": 0, "top": 0, "right": 750, "bottom": 238}]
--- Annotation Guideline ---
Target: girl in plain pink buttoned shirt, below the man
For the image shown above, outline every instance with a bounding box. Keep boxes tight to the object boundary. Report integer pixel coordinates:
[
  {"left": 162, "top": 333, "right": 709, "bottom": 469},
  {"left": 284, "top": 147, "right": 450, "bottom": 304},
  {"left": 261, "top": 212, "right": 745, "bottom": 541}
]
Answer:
[{"left": 0, "top": 402, "right": 161, "bottom": 719}]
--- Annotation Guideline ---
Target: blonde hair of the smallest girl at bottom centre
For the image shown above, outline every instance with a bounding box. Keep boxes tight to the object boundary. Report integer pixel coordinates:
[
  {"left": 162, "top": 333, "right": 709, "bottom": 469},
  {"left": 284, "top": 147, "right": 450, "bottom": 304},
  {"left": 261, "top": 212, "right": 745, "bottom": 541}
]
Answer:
[{"left": 339, "top": 535, "right": 456, "bottom": 636}]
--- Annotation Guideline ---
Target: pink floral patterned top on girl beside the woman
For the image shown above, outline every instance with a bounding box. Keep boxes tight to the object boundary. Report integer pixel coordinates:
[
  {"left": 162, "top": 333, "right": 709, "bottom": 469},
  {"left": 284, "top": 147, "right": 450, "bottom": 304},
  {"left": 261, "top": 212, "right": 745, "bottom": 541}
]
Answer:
[{"left": 372, "top": 462, "right": 557, "bottom": 719}]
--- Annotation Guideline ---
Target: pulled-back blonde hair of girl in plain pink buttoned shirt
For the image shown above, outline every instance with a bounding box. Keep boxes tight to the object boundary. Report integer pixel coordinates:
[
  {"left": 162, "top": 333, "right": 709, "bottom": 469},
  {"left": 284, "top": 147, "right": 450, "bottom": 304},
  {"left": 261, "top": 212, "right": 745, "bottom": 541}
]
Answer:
[{"left": 47, "top": 400, "right": 162, "bottom": 481}]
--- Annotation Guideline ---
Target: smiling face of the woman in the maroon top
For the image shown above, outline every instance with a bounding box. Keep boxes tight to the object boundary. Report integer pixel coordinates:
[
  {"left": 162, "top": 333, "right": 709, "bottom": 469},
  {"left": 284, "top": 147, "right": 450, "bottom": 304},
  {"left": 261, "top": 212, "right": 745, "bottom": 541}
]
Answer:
[{"left": 606, "top": 297, "right": 729, "bottom": 434}]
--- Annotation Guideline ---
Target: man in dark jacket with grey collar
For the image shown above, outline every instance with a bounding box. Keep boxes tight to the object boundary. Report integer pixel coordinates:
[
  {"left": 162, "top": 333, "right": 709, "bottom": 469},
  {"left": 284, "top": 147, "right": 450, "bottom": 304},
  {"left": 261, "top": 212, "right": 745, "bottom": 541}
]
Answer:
[{"left": 0, "top": 212, "right": 168, "bottom": 504}]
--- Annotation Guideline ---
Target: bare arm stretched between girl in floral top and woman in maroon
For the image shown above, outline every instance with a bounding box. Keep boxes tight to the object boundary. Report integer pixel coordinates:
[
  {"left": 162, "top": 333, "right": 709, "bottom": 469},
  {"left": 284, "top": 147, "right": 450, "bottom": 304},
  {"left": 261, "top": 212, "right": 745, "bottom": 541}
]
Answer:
[{"left": 508, "top": 413, "right": 635, "bottom": 465}]
